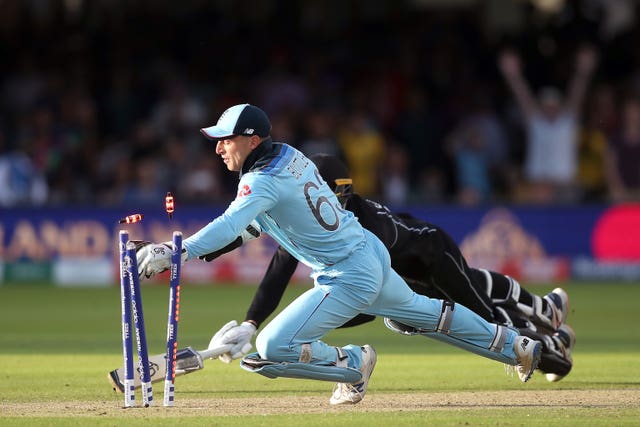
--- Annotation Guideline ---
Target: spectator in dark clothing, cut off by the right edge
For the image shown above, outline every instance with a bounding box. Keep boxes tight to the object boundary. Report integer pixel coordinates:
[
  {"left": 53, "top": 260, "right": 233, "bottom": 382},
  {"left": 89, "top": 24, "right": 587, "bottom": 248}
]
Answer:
[{"left": 606, "top": 97, "right": 640, "bottom": 202}]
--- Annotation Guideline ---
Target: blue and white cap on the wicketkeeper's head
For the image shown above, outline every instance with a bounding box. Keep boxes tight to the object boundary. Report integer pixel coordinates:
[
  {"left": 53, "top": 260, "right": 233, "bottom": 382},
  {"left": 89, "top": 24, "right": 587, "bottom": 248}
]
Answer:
[{"left": 200, "top": 104, "right": 271, "bottom": 140}]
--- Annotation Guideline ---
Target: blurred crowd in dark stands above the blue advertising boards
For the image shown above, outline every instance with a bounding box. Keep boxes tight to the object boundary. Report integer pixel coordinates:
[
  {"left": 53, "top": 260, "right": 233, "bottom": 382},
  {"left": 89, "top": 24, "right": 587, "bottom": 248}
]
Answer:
[{"left": 0, "top": 0, "right": 640, "bottom": 206}]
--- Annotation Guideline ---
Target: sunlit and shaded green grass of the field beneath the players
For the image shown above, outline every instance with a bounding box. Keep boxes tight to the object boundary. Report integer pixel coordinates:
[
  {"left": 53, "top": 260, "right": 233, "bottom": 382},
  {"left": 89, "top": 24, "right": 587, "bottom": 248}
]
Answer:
[{"left": 0, "top": 283, "right": 640, "bottom": 426}]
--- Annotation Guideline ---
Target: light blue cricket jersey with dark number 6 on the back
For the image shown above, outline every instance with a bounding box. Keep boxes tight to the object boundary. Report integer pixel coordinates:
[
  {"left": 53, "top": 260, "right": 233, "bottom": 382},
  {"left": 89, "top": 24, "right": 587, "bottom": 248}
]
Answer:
[{"left": 183, "top": 140, "right": 364, "bottom": 270}]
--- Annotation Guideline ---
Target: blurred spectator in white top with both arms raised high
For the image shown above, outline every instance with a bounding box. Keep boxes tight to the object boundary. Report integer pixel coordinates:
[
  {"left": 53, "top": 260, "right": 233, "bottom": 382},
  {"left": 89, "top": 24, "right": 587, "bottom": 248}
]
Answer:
[{"left": 499, "top": 47, "right": 597, "bottom": 203}]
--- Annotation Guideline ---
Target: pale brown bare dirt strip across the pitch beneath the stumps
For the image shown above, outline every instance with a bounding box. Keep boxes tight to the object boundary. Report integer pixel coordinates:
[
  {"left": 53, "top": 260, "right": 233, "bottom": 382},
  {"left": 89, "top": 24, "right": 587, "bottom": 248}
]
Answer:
[{"left": 0, "top": 389, "right": 640, "bottom": 417}]
